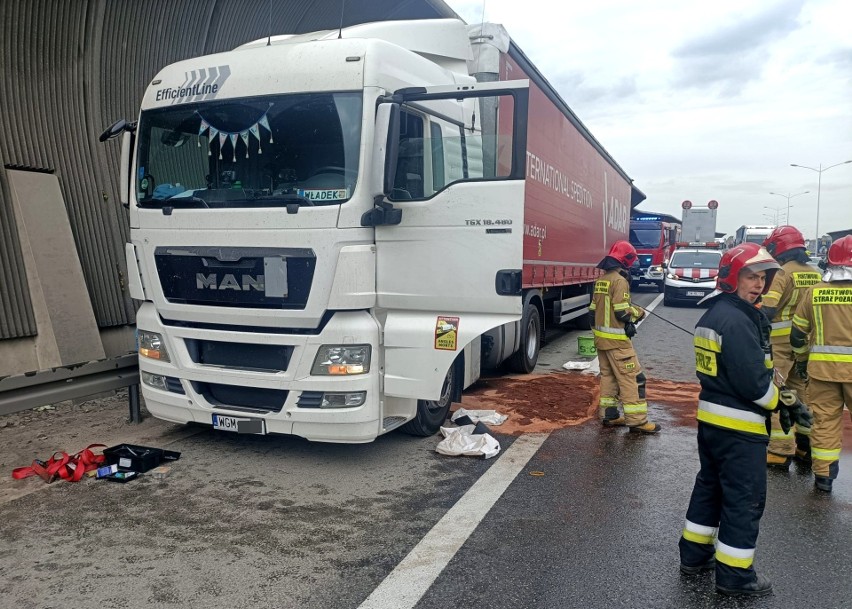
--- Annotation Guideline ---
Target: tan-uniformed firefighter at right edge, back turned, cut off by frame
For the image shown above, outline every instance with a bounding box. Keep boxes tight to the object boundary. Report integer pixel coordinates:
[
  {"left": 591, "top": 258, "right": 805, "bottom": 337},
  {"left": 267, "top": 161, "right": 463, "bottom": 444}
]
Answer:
[{"left": 790, "top": 235, "right": 852, "bottom": 493}]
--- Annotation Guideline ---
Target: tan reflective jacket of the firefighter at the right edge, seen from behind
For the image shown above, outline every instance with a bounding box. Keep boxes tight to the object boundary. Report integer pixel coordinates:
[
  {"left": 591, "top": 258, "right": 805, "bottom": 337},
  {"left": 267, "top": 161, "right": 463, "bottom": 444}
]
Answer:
[{"left": 790, "top": 281, "right": 852, "bottom": 383}]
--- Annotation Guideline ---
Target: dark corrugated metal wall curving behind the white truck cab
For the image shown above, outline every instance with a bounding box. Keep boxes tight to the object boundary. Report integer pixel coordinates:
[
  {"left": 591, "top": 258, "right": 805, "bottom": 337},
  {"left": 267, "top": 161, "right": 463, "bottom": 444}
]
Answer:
[{"left": 0, "top": 0, "right": 460, "bottom": 338}]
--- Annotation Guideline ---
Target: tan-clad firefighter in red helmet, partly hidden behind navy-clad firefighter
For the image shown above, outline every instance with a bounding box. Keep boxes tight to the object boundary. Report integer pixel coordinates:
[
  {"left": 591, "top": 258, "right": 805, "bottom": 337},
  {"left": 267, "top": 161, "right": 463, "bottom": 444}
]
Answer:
[{"left": 761, "top": 226, "right": 820, "bottom": 470}]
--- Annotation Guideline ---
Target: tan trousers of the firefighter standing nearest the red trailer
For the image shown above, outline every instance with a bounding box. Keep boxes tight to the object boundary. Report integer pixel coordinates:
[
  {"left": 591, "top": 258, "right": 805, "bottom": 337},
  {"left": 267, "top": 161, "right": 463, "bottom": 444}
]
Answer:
[{"left": 598, "top": 346, "right": 648, "bottom": 427}]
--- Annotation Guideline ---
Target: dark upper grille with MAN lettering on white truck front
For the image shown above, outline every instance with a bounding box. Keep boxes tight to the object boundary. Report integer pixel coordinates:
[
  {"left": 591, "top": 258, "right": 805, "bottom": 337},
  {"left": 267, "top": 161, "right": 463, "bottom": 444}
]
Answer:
[{"left": 154, "top": 247, "right": 316, "bottom": 309}]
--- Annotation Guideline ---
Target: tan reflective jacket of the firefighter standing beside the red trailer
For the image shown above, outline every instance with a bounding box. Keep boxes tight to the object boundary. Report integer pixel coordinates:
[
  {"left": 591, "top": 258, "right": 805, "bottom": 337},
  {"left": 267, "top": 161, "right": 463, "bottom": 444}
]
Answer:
[{"left": 589, "top": 269, "right": 644, "bottom": 351}]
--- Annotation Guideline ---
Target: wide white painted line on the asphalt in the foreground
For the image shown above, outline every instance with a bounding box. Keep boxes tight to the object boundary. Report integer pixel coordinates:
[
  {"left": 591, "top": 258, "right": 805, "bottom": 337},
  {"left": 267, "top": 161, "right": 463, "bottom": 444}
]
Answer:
[{"left": 358, "top": 434, "right": 550, "bottom": 609}]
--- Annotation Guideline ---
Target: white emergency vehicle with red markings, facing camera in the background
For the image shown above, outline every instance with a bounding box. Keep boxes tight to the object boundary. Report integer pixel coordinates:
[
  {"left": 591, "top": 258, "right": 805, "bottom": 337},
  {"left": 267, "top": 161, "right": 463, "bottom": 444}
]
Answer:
[{"left": 663, "top": 241, "right": 722, "bottom": 306}]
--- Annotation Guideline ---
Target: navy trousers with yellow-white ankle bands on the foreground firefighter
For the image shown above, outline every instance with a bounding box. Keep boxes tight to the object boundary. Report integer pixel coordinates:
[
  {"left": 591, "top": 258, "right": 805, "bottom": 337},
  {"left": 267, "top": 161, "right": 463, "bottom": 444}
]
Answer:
[{"left": 679, "top": 421, "right": 766, "bottom": 588}]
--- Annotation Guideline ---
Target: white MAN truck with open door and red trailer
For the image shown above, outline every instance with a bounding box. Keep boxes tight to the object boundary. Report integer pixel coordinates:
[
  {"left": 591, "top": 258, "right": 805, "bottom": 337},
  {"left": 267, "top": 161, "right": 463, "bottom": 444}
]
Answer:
[{"left": 102, "top": 20, "right": 644, "bottom": 442}]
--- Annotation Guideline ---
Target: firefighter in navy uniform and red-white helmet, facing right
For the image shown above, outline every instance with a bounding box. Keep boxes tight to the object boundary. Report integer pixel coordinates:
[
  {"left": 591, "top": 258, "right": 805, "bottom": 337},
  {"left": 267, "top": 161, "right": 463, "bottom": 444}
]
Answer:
[{"left": 679, "top": 243, "right": 779, "bottom": 596}]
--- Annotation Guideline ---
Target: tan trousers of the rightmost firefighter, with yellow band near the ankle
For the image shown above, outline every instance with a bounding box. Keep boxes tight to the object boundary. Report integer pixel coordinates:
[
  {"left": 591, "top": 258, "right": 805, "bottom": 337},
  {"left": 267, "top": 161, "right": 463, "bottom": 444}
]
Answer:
[{"left": 808, "top": 377, "right": 852, "bottom": 479}]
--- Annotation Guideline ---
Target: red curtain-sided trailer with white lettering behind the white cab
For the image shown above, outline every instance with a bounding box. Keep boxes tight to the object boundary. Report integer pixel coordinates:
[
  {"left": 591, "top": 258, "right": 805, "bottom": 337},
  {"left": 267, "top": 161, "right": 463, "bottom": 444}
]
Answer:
[{"left": 482, "top": 30, "right": 645, "bottom": 372}]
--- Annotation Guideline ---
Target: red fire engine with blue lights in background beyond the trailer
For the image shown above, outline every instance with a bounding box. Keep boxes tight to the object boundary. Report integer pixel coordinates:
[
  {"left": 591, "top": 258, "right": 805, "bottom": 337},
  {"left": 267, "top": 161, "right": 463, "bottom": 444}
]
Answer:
[{"left": 630, "top": 216, "right": 680, "bottom": 292}]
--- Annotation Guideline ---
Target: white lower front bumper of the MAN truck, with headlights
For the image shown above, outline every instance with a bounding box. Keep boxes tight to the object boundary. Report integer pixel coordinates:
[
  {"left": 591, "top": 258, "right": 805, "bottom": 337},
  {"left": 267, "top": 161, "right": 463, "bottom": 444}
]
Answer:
[{"left": 137, "top": 303, "right": 406, "bottom": 443}]
